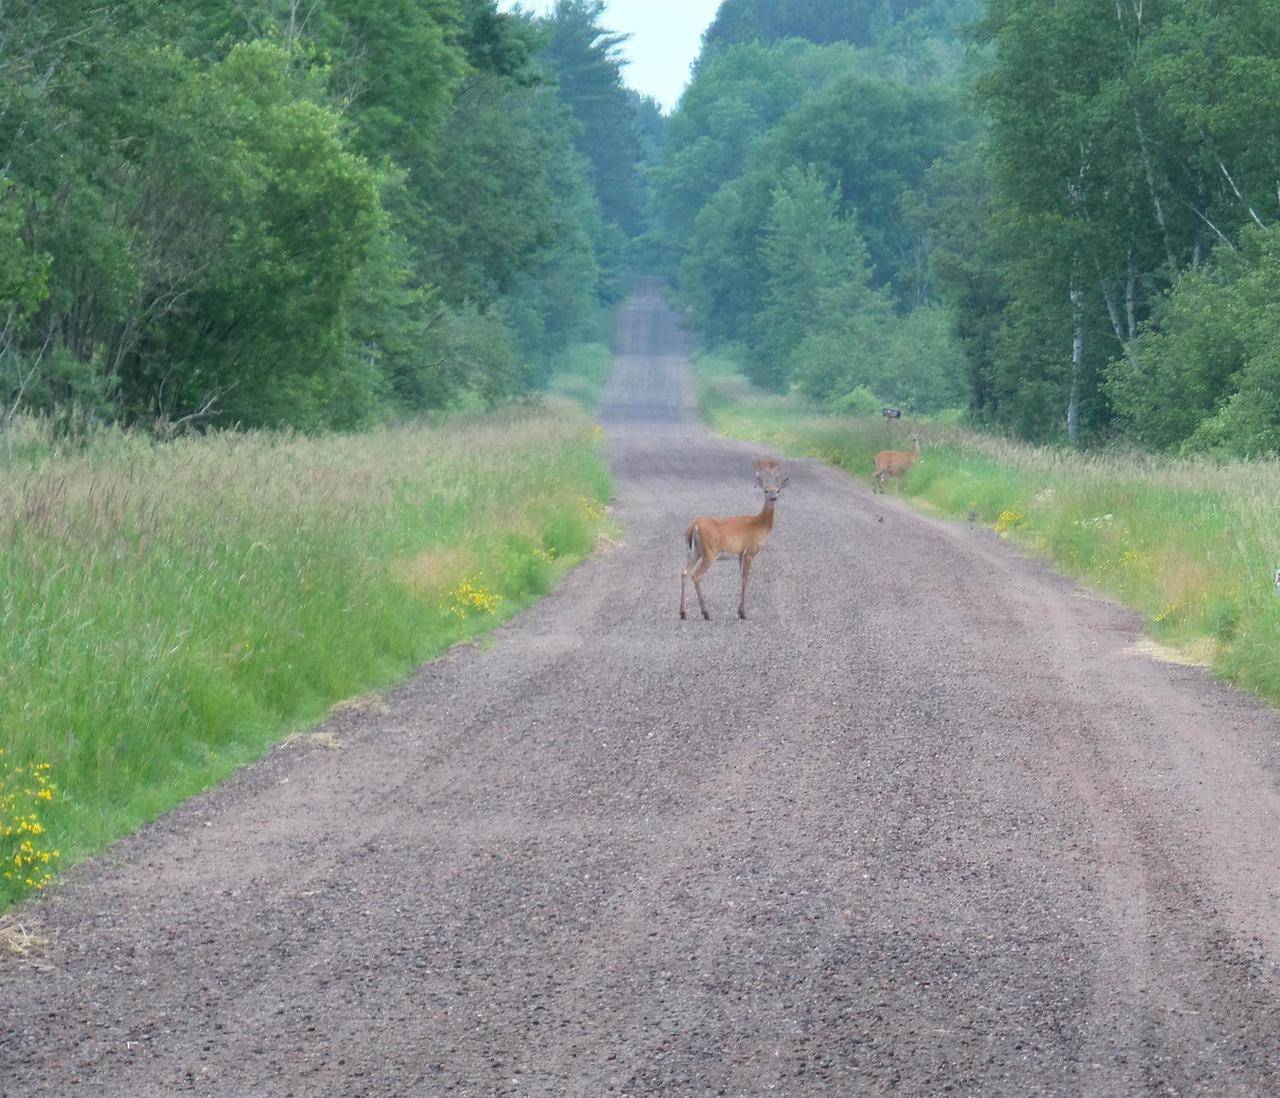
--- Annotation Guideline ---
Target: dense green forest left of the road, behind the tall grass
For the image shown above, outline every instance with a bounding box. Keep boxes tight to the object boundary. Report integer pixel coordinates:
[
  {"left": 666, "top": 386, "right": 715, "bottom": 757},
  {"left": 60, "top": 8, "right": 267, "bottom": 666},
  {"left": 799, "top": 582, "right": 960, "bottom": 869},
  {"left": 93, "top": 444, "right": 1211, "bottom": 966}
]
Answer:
[{"left": 0, "top": 0, "right": 662, "bottom": 434}]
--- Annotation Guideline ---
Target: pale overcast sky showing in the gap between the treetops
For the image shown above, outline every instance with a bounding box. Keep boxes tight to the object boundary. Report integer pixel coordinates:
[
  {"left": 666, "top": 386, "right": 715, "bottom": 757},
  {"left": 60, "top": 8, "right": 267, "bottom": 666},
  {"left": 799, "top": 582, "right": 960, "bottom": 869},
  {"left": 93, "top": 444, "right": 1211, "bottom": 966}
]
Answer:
[{"left": 498, "top": 0, "right": 721, "bottom": 110}]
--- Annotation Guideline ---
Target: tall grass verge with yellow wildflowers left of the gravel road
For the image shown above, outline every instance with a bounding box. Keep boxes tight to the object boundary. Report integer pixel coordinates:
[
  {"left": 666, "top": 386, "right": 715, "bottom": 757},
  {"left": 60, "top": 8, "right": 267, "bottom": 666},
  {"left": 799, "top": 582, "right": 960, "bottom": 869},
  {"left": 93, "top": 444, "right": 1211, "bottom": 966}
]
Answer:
[{"left": 0, "top": 406, "right": 612, "bottom": 906}]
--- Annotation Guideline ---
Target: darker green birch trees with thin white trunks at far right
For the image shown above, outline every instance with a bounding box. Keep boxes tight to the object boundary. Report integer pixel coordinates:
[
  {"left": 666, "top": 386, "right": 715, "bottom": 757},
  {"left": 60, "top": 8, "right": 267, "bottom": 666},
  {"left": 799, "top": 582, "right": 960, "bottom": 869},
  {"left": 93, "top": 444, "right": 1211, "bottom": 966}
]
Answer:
[{"left": 952, "top": 0, "right": 1280, "bottom": 449}]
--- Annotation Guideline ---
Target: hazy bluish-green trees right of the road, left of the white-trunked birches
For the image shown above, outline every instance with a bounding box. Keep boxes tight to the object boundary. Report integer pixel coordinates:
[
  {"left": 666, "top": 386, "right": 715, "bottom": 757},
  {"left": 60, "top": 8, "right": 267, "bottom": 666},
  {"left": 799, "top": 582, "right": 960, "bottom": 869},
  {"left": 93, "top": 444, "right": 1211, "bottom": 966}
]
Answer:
[{"left": 654, "top": 4, "right": 974, "bottom": 410}]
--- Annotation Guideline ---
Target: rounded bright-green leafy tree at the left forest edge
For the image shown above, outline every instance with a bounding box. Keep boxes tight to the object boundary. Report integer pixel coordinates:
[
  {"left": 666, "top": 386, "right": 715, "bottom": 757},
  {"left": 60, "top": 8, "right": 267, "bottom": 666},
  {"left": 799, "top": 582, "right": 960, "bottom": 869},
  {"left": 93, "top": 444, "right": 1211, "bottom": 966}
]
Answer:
[{"left": 120, "top": 42, "right": 383, "bottom": 425}]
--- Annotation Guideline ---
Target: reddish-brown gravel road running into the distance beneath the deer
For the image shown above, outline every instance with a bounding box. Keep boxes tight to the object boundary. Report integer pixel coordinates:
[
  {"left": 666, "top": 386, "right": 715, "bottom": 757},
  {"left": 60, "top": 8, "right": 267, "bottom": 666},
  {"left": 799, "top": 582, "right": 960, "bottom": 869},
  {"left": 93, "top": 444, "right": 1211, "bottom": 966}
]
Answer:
[{"left": 0, "top": 287, "right": 1280, "bottom": 1098}]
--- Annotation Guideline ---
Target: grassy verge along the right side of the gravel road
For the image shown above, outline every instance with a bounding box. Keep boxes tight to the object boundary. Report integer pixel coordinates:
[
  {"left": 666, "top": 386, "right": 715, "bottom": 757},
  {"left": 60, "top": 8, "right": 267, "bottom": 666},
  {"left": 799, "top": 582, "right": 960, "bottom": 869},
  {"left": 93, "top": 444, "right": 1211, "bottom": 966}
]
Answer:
[{"left": 698, "top": 354, "right": 1280, "bottom": 703}]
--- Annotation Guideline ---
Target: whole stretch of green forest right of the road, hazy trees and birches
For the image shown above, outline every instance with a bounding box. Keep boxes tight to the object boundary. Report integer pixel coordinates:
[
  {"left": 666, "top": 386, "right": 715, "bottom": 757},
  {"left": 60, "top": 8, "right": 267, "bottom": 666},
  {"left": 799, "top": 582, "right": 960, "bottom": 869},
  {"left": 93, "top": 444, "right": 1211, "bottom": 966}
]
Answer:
[{"left": 665, "top": 0, "right": 1280, "bottom": 453}]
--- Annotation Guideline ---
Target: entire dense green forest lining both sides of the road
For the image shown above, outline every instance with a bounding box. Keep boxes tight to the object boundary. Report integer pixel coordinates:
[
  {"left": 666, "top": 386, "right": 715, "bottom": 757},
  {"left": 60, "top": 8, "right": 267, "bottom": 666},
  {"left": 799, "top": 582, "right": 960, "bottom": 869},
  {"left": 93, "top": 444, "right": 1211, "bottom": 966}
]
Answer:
[{"left": 10, "top": 0, "right": 1280, "bottom": 453}]
